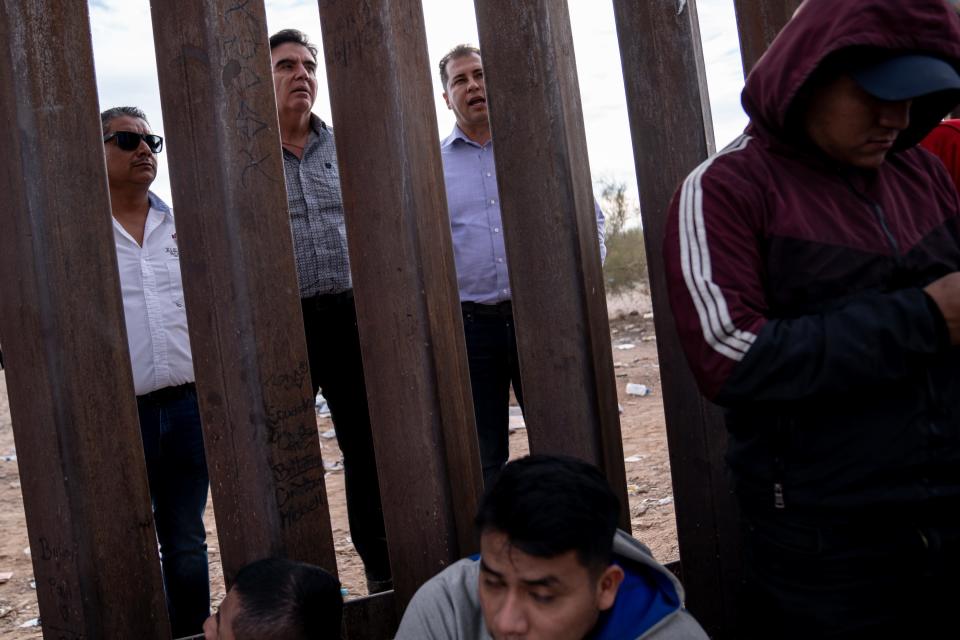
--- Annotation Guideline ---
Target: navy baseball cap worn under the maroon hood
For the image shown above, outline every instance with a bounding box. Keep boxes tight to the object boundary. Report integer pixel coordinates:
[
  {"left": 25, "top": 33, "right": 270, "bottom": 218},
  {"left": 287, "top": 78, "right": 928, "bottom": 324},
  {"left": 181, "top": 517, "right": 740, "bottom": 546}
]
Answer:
[{"left": 851, "top": 54, "right": 960, "bottom": 101}]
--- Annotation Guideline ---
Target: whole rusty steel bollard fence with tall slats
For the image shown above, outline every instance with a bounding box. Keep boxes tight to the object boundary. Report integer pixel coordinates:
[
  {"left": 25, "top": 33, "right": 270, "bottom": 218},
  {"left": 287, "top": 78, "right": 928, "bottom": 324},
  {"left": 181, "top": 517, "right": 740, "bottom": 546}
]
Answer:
[{"left": 0, "top": 0, "right": 799, "bottom": 640}]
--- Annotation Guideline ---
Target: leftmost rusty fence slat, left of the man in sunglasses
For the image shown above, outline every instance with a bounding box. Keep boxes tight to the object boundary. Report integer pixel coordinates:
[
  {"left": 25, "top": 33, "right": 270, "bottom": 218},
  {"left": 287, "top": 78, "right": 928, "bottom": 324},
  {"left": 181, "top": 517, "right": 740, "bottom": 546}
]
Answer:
[{"left": 0, "top": 0, "right": 170, "bottom": 640}]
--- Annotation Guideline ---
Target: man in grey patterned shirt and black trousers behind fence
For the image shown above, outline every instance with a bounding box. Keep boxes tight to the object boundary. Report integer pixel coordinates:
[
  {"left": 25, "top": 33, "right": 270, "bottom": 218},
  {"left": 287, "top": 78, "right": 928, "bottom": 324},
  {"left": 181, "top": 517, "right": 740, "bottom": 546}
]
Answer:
[{"left": 270, "top": 29, "right": 392, "bottom": 593}]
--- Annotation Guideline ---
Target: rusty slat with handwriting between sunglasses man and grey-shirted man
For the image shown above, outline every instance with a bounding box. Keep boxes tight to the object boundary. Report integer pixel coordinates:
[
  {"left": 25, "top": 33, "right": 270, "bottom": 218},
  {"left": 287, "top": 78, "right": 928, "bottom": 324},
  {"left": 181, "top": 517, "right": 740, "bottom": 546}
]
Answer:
[{"left": 151, "top": 0, "right": 337, "bottom": 584}]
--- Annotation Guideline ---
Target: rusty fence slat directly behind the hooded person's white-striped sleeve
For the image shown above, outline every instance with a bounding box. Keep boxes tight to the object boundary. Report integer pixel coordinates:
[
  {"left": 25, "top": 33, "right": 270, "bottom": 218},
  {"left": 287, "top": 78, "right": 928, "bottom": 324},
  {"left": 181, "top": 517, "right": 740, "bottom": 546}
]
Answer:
[{"left": 614, "top": 0, "right": 740, "bottom": 638}]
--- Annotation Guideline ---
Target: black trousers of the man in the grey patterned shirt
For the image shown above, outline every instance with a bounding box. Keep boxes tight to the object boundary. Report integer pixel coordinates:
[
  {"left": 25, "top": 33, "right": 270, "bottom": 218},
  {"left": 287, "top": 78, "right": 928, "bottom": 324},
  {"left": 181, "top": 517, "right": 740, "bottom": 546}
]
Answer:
[{"left": 301, "top": 291, "right": 391, "bottom": 581}]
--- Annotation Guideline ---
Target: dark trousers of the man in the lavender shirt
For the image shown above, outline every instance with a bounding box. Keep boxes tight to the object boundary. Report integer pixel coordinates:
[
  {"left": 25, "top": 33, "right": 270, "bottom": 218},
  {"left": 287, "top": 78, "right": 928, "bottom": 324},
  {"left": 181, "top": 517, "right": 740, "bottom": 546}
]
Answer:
[{"left": 461, "top": 302, "right": 523, "bottom": 486}]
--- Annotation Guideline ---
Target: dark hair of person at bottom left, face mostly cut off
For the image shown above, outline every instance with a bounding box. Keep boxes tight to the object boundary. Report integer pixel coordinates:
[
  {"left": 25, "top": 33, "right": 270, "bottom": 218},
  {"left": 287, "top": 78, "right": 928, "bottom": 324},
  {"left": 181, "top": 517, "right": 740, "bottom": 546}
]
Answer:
[{"left": 232, "top": 558, "right": 343, "bottom": 640}]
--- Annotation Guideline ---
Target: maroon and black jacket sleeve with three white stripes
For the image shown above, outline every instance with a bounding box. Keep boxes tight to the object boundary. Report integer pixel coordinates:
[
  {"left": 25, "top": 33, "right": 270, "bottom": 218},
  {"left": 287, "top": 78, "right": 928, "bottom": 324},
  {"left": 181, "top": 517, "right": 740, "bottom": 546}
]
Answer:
[{"left": 664, "top": 138, "right": 956, "bottom": 406}]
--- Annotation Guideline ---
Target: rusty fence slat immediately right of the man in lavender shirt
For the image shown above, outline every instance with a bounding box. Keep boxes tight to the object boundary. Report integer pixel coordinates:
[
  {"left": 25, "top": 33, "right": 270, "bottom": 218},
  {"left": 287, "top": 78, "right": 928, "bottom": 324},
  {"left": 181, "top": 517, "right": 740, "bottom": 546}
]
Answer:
[{"left": 475, "top": 0, "right": 630, "bottom": 529}]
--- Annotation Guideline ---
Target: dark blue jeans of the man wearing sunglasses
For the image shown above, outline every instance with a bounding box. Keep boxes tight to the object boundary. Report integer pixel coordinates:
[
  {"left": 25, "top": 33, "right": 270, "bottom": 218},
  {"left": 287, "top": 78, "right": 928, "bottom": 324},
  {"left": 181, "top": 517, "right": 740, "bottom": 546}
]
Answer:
[{"left": 137, "top": 384, "right": 210, "bottom": 638}]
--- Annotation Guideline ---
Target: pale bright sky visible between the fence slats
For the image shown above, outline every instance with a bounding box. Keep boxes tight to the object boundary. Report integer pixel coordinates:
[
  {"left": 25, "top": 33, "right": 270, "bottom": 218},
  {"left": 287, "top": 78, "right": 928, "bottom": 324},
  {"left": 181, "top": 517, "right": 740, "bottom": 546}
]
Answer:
[{"left": 89, "top": 0, "right": 746, "bottom": 210}]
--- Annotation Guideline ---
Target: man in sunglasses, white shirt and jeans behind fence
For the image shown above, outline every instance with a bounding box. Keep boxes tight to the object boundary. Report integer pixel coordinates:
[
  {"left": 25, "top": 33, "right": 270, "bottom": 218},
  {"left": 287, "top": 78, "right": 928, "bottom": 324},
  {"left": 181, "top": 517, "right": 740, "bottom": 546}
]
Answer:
[{"left": 100, "top": 107, "right": 210, "bottom": 638}]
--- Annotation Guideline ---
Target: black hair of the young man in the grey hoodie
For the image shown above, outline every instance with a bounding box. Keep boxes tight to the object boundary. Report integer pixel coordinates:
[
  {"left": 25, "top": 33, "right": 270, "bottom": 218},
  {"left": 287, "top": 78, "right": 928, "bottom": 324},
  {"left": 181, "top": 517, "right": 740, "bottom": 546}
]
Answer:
[{"left": 474, "top": 455, "right": 620, "bottom": 571}]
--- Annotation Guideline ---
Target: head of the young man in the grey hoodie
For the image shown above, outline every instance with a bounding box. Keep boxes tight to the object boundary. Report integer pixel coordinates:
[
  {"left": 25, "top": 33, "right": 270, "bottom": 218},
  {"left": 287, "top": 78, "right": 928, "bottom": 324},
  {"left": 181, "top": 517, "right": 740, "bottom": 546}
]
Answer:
[{"left": 476, "top": 455, "right": 624, "bottom": 640}]
